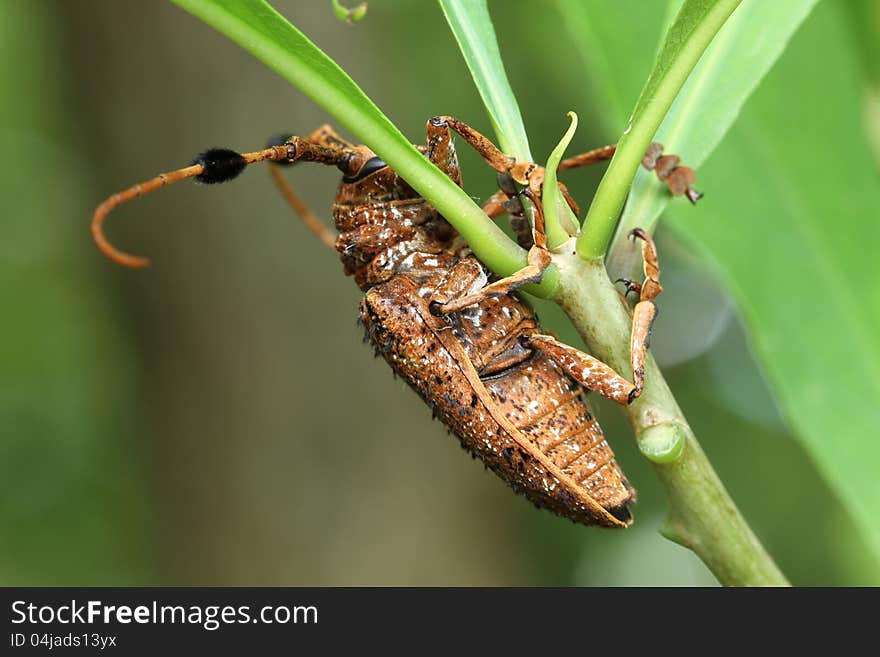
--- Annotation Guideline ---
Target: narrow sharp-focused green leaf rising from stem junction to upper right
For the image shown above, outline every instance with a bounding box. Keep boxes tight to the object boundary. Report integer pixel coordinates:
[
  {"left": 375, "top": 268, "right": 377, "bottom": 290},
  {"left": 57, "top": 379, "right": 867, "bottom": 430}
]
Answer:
[{"left": 577, "top": 0, "right": 740, "bottom": 259}]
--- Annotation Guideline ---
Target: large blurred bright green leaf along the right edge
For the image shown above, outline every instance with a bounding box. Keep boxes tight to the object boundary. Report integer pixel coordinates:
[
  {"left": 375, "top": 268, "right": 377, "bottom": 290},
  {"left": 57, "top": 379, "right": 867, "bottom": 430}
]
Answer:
[{"left": 576, "top": 0, "right": 880, "bottom": 554}]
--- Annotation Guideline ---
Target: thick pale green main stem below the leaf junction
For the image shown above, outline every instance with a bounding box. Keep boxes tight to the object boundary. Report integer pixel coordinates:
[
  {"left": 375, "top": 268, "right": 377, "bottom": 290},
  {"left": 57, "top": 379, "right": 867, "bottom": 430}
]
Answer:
[{"left": 554, "top": 250, "right": 788, "bottom": 586}]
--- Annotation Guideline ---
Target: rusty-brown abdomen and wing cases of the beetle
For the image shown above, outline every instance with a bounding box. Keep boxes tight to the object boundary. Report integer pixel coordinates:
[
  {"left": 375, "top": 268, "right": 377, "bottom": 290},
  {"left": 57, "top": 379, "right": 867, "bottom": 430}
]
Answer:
[{"left": 361, "top": 275, "right": 635, "bottom": 526}]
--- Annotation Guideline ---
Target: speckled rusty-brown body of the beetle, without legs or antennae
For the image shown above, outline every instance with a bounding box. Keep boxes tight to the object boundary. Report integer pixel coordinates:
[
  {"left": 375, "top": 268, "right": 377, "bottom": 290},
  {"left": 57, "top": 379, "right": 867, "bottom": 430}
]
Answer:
[{"left": 334, "top": 161, "right": 635, "bottom": 527}]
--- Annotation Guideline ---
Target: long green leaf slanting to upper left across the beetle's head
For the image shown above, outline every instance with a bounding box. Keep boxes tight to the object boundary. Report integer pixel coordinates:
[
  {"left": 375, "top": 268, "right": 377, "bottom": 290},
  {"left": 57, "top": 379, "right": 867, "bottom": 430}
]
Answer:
[{"left": 174, "top": 0, "right": 556, "bottom": 295}]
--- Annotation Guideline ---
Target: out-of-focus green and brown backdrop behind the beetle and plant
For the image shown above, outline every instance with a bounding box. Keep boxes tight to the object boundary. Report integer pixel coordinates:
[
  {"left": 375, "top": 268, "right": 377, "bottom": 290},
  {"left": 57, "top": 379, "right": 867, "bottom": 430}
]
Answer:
[{"left": 0, "top": 0, "right": 880, "bottom": 585}]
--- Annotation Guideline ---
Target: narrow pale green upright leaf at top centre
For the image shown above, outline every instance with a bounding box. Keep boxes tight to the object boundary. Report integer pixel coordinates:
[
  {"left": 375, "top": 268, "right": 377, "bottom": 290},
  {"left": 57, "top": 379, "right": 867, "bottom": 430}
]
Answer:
[{"left": 439, "top": 0, "right": 532, "bottom": 162}]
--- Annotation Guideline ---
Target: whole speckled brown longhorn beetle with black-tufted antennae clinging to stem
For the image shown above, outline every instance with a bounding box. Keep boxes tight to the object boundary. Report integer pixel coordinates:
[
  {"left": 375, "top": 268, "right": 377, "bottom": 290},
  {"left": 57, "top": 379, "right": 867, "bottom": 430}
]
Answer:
[{"left": 92, "top": 116, "right": 701, "bottom": 527}]
